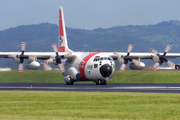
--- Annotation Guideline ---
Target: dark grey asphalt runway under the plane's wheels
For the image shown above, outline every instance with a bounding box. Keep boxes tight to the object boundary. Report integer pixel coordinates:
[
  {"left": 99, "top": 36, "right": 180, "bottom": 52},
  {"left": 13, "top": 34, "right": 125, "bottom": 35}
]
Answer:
[{"left": 0, "top": 83, "right": 180, "bottom": 93}]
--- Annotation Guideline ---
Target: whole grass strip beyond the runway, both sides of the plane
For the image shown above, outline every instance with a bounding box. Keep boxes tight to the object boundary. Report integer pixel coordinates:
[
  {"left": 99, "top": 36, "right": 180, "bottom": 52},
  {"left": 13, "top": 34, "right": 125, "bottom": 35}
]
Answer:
[{"left": 0, "top": 70, "right": 180, "bottom": 83}]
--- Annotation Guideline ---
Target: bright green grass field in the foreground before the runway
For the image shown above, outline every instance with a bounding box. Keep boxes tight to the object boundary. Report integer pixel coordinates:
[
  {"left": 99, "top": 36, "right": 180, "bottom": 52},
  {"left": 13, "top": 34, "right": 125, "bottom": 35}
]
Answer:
[{"left": 0, "top": 91, "right": 180, "bottom": 120}]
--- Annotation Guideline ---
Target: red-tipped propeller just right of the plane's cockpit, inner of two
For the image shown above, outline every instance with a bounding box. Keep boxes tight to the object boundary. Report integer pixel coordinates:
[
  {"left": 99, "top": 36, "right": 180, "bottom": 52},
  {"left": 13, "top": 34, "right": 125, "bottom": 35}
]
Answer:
[{"left": 114, "top": 44, "right": 140, "bottom": 72}]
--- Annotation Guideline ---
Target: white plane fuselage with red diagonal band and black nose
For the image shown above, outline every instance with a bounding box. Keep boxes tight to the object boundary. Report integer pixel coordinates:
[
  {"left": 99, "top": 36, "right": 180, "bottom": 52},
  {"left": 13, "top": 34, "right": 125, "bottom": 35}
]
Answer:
[{"left": 62, "top": 52, "right": 115, "bottom": 81}]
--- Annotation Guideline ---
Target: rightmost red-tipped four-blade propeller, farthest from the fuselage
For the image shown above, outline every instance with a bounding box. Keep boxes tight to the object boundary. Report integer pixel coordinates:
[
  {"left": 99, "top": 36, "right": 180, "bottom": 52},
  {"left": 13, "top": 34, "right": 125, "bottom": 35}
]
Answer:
[{"left": 150, "top": 45, "right": 174, "bottom": 70}]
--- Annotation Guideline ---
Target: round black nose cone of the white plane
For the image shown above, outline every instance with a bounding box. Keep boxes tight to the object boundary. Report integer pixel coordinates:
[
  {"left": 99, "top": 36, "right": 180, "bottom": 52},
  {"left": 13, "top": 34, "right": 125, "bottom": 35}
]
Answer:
[{"left": 100, "top": 64, "right": 112, "bottom": 77}]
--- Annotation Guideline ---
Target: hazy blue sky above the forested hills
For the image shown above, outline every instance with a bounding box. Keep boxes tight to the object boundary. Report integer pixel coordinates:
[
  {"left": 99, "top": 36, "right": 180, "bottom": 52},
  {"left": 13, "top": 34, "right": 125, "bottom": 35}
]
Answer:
[{"left": 0, "top": 0, "right": 180, "bottom": 31}]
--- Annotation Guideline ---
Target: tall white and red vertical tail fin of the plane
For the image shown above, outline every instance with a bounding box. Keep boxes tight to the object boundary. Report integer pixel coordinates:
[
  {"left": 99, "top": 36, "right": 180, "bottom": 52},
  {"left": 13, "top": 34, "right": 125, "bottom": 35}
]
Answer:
[{"left": 58, "top": 6, "right": 72, "bottom": 52}]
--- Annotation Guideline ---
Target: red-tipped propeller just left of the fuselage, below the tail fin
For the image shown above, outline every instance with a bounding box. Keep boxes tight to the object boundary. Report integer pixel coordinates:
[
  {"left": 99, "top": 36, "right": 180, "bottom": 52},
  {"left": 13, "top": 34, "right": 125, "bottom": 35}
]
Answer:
[{"left": 45, "top": 44, "right": 65, "bottom": 73}]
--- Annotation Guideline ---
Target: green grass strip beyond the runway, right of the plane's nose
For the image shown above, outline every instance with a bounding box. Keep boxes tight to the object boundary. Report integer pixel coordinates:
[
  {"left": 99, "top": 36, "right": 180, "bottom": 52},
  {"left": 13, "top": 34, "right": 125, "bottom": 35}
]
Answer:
[{"left": 109, "top": 71, "right": 180, "bottom": 83}]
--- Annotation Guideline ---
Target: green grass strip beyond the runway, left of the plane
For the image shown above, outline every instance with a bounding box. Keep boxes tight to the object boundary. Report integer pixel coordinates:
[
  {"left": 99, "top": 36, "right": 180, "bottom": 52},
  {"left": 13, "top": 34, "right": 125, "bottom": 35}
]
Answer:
[{"left": 0, "top": 70, "right": 64, "bottom": 83}]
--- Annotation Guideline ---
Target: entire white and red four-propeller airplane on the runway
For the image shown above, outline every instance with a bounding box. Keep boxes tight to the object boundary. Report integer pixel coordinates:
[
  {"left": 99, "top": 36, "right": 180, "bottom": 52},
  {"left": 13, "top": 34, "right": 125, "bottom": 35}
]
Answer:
[{"left": 0, "top": 6, "right": 180, "bottom": 85}]
